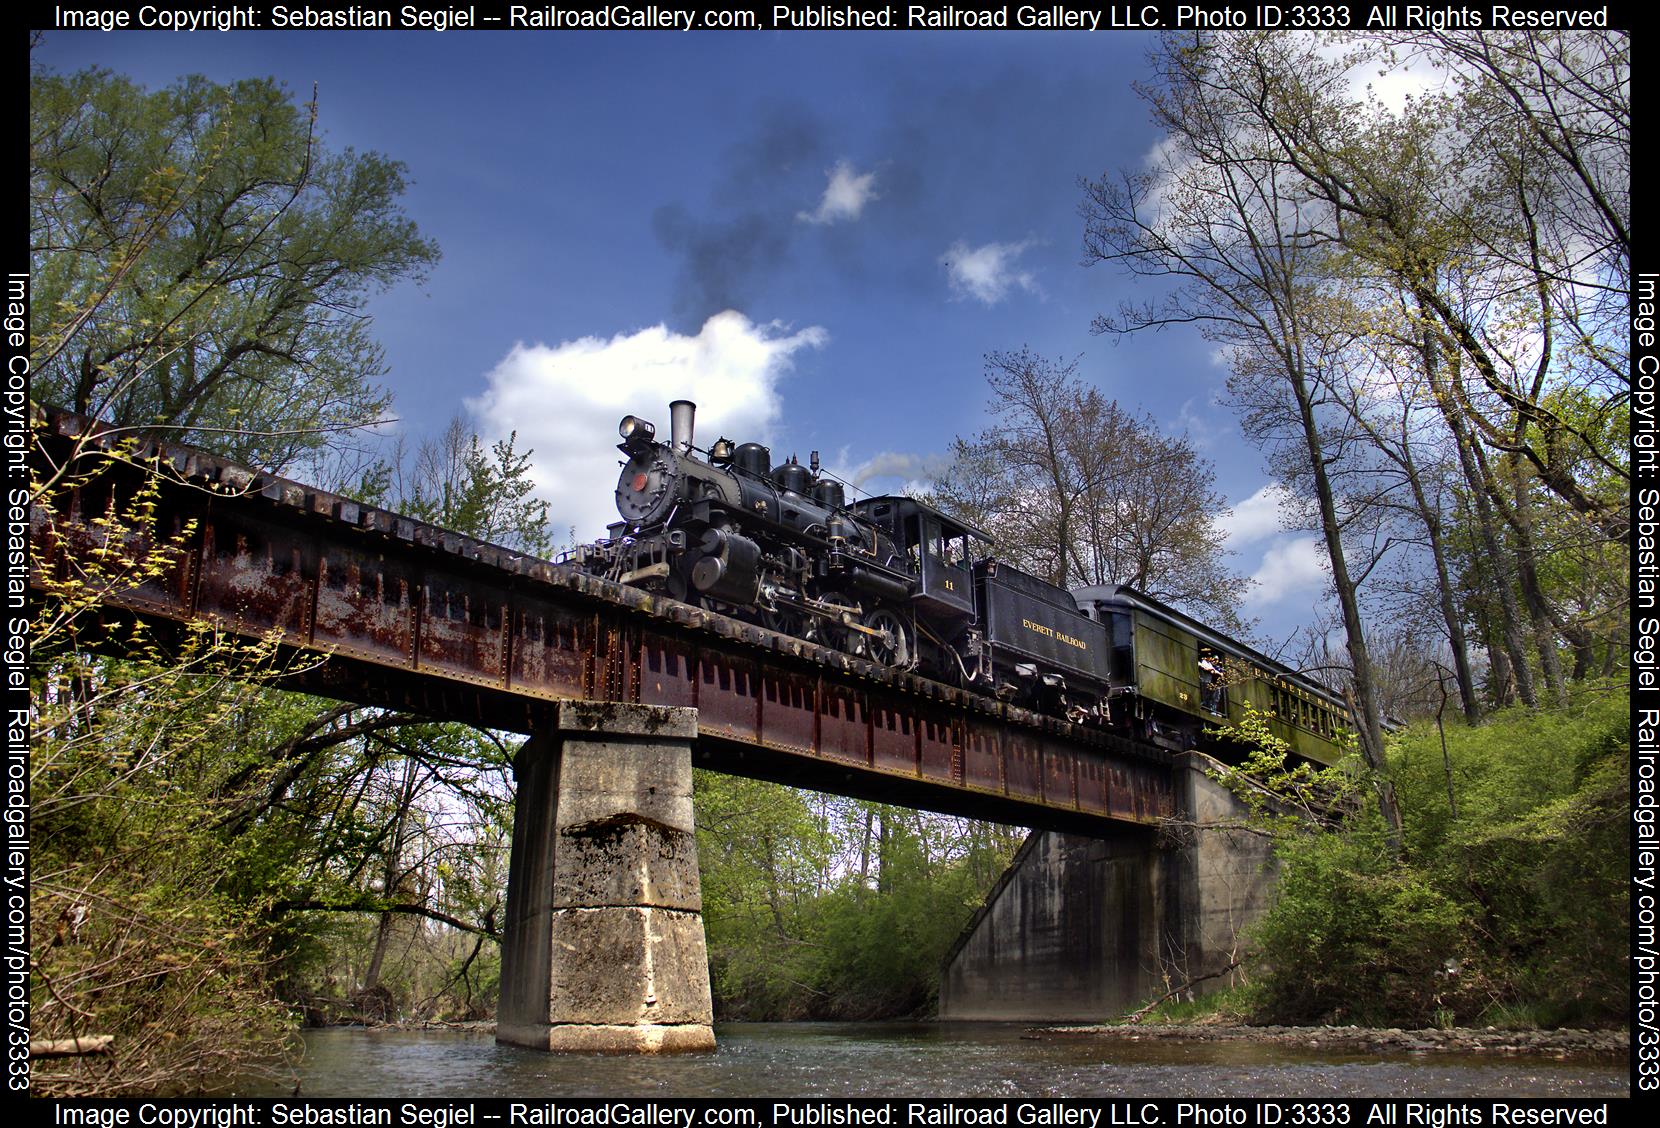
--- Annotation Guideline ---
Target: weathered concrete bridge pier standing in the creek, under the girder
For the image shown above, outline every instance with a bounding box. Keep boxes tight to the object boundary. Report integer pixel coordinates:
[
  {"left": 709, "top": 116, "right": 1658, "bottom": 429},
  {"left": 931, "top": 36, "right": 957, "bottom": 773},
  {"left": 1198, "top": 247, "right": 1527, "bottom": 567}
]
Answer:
[{"left": 496, "top": 702, "right": 715, "bottom": 1053}]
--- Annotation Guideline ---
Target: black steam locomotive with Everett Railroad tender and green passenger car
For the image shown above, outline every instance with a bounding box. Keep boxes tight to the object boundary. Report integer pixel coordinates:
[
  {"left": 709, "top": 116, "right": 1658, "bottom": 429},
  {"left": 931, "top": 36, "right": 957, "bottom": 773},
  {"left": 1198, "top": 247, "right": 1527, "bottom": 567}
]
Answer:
[{"left": 574, "top": 400, "right": 1346, "bottom": 763}]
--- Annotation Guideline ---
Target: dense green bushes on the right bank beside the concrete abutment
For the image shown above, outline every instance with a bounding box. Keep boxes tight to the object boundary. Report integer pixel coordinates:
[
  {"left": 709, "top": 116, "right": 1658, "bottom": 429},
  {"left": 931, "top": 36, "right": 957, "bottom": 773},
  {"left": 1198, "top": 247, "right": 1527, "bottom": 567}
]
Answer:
[{"left": 1253, "top": 685, "right": 1630, "bottom": 1025}]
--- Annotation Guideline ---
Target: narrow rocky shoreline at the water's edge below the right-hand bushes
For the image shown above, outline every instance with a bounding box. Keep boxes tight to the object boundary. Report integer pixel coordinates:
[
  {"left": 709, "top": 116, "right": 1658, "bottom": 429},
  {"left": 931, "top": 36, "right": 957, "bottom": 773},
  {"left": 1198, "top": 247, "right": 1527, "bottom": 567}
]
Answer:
[{"left": 1033, "top": 1023, "right": 1632, "bottom": 1058}]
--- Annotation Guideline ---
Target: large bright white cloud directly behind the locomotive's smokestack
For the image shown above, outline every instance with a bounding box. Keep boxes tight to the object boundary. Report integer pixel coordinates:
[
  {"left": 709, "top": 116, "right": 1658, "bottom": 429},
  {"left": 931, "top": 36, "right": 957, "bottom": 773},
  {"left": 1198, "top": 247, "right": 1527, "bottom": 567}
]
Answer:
[{"left": 466, "top": 310, "right": 830, "bottom": 542}]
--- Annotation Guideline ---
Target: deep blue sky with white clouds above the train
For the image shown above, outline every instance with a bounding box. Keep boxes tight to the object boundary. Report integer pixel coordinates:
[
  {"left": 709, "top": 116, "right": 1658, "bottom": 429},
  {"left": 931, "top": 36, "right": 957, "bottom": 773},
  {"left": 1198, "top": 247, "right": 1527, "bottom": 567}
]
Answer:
[{"left": 35, "top": 32, "right": 1325, "bottom": 640}]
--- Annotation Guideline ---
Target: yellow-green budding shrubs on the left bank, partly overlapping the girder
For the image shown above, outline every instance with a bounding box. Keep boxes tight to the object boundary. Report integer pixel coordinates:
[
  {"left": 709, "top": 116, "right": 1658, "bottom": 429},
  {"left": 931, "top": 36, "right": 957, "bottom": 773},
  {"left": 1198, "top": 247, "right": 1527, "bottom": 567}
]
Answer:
[{"left": 30, "top": 447, "right": 305, "bottom": 1095}]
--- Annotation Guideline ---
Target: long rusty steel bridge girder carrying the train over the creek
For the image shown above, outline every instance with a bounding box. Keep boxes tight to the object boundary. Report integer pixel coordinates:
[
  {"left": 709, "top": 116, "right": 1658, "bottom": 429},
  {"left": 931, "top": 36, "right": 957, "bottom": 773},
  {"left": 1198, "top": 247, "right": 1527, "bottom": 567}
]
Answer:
[{"left": 22, "top": 413, "right": 1174, "bottom": 831}]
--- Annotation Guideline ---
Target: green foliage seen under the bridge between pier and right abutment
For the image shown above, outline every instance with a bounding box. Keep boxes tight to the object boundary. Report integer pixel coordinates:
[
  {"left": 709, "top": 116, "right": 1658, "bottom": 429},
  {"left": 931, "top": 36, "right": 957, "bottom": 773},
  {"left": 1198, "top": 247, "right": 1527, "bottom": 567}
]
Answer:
[{"left": 697, "top": 773, "right": 1019, "bottom": 1020}]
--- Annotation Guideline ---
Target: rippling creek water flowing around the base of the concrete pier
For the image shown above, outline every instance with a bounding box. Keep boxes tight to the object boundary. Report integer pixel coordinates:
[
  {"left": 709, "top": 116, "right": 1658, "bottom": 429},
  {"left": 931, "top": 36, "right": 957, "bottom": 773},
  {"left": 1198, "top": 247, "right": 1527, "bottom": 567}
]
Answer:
[{"left": 252, "top": 1023, "right": 1630, "bottom": 1098}]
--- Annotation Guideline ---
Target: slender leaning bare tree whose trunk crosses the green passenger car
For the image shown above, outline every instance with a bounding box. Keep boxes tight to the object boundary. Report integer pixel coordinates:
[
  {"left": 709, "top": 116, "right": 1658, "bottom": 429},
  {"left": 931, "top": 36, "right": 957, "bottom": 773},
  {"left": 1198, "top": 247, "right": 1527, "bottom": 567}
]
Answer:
[{"left": 1082, "top": 33, "right": 1399, "bottom": 828}]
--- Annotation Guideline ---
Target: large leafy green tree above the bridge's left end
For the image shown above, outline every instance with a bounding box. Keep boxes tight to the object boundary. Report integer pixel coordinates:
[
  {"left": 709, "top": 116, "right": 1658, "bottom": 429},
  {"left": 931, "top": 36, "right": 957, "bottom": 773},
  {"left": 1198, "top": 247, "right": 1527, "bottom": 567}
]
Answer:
[{"left": 28, "top": 68, "right": 438, "bottom": 468}]
